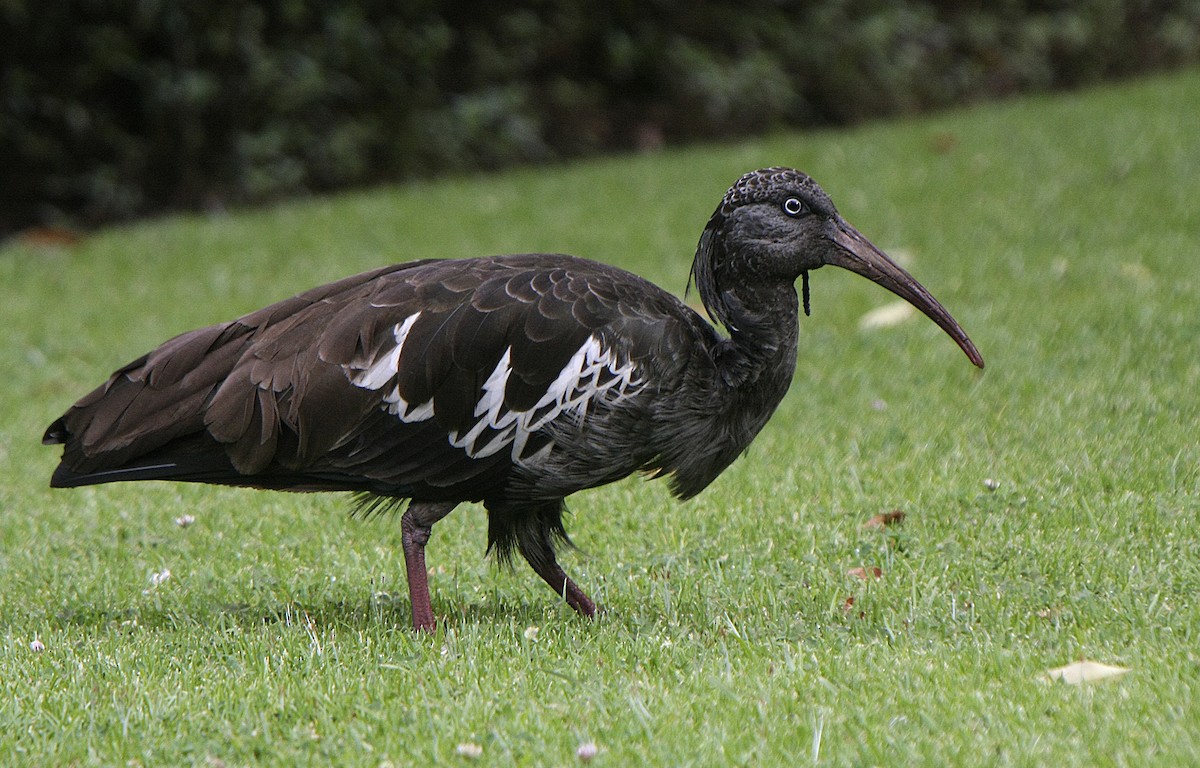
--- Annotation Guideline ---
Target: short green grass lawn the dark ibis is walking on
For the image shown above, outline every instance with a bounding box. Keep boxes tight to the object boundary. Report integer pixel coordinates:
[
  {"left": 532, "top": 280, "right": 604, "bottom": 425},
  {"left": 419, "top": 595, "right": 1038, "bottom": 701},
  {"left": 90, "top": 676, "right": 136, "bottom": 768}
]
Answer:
[{"left": 0, "top": 71, "right": 1200, "bottom": 766}]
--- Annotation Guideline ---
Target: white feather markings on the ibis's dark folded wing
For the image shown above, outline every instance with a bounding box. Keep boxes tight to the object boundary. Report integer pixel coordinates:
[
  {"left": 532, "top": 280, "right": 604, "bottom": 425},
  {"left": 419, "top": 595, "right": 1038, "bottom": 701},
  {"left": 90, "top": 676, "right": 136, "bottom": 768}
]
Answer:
[{"left": 347, "top": 312, "right": 644, "bottom": 462}]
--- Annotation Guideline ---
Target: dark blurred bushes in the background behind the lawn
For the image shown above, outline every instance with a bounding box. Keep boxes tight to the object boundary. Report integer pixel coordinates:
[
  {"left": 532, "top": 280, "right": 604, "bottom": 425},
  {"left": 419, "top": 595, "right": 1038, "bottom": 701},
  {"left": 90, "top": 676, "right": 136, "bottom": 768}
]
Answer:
[{"left": 0, "top": 0, "right": 1200, "bottom": 232}]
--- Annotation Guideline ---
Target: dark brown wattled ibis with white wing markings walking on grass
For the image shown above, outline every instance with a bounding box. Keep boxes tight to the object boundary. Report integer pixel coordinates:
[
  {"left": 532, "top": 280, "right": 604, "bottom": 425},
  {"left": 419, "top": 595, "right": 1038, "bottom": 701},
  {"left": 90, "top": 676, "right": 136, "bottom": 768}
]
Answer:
[{"left": 43, "top": 167, "right": 984, "bottom": 631}]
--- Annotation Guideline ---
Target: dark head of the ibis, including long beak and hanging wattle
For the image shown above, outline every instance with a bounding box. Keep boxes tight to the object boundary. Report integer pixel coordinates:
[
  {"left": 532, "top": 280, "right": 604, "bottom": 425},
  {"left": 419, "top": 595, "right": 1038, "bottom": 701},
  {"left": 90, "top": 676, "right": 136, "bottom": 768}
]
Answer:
[{"left": 691, "top": 168, "right": 983, "bottom": 368}]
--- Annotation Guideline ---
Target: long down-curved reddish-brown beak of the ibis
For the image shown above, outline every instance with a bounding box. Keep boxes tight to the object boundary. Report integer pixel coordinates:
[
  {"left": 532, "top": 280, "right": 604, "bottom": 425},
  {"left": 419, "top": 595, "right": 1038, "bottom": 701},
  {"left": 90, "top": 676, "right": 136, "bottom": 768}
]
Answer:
[{"left": 826, "top": 218, "right": 983, "bottom": 368}]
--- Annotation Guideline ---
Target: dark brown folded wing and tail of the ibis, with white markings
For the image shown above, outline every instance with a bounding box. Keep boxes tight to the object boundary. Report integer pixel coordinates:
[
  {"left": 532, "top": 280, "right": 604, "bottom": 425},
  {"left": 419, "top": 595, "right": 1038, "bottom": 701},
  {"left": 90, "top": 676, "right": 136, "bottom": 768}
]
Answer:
[{"left": 46, "top": 254, "right": 694, "bottom": 499}]
